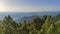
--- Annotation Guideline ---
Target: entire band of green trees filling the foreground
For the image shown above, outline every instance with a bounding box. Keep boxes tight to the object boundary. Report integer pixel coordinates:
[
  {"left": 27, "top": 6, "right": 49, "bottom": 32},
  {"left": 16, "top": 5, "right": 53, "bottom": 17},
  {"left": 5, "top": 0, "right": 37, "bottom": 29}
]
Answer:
[{"left": 0, "top": 15, "right": 60, "bottom": 34}]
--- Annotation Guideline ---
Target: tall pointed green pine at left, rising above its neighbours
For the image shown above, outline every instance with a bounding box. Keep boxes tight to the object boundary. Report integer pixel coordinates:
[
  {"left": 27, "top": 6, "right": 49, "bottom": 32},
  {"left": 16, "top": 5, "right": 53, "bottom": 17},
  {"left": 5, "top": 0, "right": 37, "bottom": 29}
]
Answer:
[{"left": 3, "top": 15, "right": 16, "bottom": 34}]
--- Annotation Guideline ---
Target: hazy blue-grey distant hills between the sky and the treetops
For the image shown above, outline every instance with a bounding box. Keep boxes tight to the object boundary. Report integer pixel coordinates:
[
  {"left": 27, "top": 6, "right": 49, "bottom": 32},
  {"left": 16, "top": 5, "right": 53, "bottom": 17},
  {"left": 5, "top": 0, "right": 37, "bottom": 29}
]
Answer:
[{"left": 0, "top": 11, "right": 60, "bottom": 22}]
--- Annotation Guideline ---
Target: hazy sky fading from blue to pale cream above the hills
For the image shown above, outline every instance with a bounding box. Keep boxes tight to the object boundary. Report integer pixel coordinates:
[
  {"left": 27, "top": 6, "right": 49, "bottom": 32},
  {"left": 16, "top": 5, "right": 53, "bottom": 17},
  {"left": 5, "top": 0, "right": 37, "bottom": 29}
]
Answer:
[{"left": 0, "top": 0, "right": 60, "bottom": 12}]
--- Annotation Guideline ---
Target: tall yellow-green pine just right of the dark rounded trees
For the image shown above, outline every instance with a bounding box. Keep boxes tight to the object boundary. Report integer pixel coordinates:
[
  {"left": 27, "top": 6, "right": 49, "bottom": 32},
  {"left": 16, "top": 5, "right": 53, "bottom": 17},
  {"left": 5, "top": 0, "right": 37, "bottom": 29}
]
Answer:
[{"left": 42, "top": 16, "right": 52, "bottom": 34}]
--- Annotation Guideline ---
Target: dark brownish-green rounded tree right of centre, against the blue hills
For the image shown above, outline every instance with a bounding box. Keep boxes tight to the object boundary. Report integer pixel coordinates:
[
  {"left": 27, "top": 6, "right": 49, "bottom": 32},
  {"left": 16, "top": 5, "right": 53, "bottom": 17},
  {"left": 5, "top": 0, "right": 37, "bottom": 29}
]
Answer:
[{"left": 32, "top": 16, "right": 43, "bottom": 30}]
